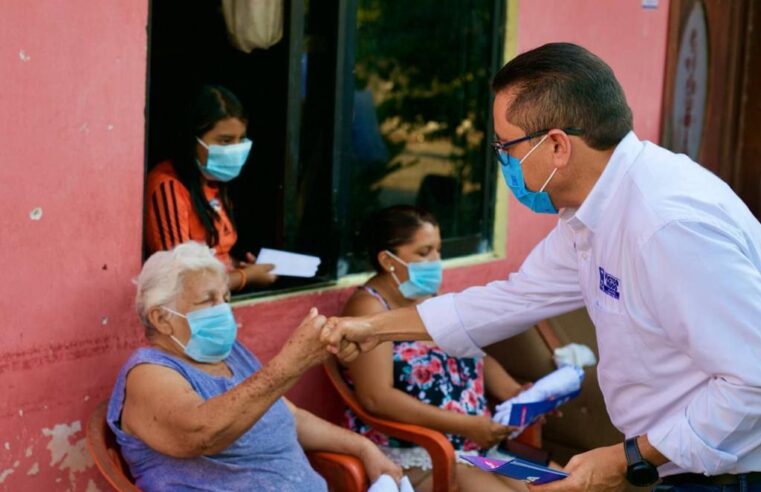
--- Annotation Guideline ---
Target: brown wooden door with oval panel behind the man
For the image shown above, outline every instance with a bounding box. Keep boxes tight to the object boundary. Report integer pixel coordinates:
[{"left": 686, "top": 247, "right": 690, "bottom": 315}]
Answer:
[{"left": 661, "top": 0, "right": 761, "bottom": 217}]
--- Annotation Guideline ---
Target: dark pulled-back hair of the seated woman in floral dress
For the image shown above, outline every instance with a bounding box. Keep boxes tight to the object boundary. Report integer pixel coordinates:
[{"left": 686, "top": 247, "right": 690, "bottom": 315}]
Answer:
[{"left": 362, "top": 205, "right": 439, "bottom": 273}]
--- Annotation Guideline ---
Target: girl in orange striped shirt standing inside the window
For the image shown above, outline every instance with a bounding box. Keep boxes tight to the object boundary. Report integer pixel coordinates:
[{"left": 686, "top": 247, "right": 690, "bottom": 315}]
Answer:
[{"left": 145, "top": 86, "right": 275, "bottom": 290}]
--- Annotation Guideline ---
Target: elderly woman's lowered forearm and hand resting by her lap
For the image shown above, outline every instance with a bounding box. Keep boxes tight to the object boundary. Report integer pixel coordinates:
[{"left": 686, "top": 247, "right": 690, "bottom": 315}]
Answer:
[{"left": 286, "top": 400, "right": 402, "bottom": 482}]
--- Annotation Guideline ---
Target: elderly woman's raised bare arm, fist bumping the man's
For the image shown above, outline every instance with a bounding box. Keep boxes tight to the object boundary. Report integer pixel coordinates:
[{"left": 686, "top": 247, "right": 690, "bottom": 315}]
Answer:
[{"left": 121, "top": 309, "right": 327, "bottom": 458}]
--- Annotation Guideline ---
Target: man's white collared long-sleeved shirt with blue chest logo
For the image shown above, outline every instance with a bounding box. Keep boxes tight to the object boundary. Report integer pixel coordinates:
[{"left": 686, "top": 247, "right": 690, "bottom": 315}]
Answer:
[{"left": 418, "top": 133, "right": 761, "bottom": 475}]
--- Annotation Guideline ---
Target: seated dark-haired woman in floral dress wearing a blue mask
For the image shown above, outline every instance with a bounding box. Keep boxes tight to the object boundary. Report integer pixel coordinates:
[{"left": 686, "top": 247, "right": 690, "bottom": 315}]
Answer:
[{"left": 343, "top": 205, "right": 526, "bottom": 492}]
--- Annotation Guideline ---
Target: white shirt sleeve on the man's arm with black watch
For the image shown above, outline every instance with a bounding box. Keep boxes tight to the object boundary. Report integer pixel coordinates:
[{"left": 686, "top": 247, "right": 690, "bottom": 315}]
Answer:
[{"left": 637, "top": 222, "right": 761, "bottom": 475}]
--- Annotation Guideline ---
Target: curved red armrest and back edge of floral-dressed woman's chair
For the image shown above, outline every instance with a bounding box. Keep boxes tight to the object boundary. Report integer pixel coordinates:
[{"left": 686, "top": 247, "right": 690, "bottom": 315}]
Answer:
[{"left": 323, "top": 357, "right": 457, "bottom": 492}]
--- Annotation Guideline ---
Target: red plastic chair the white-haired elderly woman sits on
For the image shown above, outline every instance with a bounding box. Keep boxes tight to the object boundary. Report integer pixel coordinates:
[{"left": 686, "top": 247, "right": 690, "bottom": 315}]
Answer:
[{"left": 87, "top": 401, "right": 369, "bottom": 492}]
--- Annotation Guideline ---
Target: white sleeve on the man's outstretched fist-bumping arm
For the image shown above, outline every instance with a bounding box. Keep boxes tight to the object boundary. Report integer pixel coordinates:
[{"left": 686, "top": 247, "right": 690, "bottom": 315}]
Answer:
[{"left": 417, "top": 224, "right": 584, "bottom": 357}]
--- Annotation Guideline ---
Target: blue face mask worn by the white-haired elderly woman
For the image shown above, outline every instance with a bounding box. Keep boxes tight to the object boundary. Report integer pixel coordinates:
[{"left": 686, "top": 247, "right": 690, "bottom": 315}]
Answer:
[{"left": 164, "top": 302, "right": 238, "bottom": 362}]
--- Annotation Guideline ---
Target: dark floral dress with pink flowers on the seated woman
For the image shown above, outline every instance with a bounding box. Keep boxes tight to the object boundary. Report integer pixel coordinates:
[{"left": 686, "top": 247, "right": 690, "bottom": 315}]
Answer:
[{"left": 344, "top": 286, "right": 491, "bottom": 469}]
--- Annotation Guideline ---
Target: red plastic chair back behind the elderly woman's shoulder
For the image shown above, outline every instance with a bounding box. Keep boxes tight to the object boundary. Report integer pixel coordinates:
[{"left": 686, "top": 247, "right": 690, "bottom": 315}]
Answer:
[{"left": 86, "top": 401, "right": 140, "bottom": 492}]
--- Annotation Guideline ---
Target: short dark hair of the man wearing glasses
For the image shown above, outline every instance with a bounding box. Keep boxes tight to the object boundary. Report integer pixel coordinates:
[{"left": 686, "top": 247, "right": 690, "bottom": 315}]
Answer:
[{"left": 492, "top": 43, "right": 632, "bottom": 150}]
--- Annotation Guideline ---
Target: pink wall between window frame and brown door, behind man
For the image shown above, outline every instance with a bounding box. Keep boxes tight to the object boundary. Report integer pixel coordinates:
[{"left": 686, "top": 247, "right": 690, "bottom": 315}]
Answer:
[{"left": 507, "top": 0, "right": 669, "bottom": 270}]
